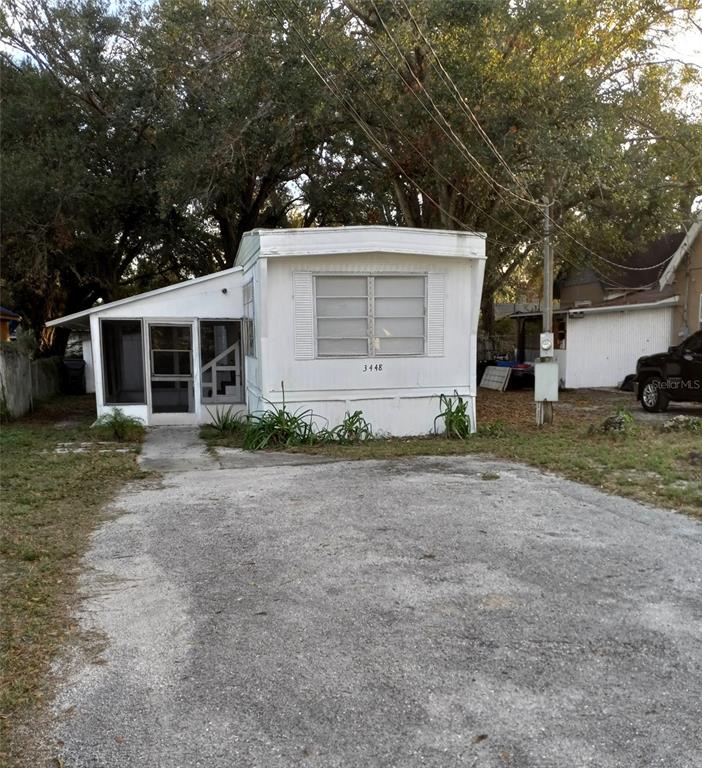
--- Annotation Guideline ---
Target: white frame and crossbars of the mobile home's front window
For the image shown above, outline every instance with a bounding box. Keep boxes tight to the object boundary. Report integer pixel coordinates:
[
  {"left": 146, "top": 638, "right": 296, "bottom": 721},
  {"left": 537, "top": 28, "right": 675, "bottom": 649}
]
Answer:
[{"left": 312, "top": 272, "right": 429, "bottom": 360}]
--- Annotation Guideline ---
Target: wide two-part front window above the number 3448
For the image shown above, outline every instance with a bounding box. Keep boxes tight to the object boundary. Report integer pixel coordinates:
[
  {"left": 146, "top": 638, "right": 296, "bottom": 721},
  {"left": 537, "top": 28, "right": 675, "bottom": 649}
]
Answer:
[{"left": 315, "top": 275, "right": 426, "bottom": 357}]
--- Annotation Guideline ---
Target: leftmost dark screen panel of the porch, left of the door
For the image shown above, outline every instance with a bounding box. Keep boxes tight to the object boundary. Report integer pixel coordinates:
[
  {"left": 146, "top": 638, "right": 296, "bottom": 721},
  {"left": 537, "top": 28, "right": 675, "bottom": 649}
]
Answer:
[{"left": 100, "top": 320, "right": 146, "bottom": 405}]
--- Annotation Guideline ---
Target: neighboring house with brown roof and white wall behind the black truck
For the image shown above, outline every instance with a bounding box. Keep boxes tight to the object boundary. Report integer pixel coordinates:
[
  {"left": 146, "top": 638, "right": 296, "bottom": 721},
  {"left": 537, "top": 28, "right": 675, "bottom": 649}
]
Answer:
[{"left": 512, "top": 218, "right": 702, "bottom": 389}]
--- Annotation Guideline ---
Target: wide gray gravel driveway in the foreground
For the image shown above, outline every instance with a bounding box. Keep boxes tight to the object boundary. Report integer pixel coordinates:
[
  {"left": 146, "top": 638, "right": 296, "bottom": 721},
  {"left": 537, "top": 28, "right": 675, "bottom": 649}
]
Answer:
[{"left": 54, "top": 436, "right": 702, "bottom": 768}]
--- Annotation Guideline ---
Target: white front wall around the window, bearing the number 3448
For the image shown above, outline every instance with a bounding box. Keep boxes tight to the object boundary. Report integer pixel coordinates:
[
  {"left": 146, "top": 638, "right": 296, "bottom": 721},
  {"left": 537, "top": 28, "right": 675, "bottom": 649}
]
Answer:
[{"left": 256, "top": 254, "right": 484, "bottom": 435}]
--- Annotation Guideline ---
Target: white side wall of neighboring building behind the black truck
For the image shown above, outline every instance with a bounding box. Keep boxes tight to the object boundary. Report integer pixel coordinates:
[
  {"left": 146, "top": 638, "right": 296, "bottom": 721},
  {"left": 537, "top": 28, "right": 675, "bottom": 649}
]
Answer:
[{"left": 565, "top": 306, "right": 673, "bottom": 389}]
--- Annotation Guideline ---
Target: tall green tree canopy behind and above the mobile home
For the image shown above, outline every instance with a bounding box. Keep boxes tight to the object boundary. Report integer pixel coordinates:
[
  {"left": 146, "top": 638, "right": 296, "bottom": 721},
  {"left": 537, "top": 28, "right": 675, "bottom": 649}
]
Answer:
[{"left": 0, "top": 0, "right": 702, "bottom": 352}]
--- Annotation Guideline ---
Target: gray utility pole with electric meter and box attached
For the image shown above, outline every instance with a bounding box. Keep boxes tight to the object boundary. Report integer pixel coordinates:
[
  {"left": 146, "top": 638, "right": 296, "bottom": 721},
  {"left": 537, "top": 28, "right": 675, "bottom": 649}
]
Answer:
[{"left": 534, "top": 195, "right": 558, "bottom": 426}]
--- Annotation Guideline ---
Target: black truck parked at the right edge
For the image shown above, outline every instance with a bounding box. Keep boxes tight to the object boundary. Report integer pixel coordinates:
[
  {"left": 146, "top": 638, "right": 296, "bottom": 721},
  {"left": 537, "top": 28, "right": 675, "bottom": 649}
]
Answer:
[{"left": 636, "top": 331, "right": 702, "bottom": 413}]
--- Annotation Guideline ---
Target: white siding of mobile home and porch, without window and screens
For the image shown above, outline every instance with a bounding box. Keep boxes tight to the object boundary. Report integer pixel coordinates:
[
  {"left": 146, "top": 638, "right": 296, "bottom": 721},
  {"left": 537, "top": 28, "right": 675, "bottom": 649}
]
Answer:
[{"left": 71, "top": 227, "right": 485, "bottom": 435}]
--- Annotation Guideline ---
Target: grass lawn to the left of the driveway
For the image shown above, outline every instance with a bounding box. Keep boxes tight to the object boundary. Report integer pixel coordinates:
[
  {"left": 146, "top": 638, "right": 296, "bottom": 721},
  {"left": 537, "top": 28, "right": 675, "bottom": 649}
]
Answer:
[{"left": 0, "top": 396, "right": 144, "bottom": 765}]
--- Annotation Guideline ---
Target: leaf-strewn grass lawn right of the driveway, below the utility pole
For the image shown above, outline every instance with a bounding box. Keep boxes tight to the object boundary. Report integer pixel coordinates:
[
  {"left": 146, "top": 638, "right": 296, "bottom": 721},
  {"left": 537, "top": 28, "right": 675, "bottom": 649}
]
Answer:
[{"left": 202, "top": 390, "right": 702, "bottom": 518}]
